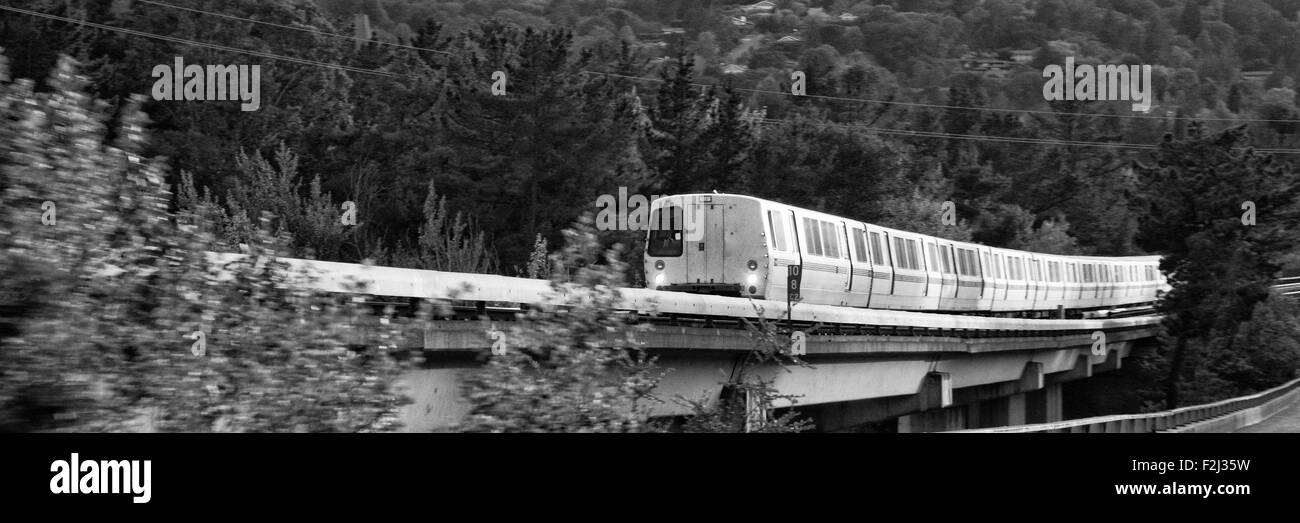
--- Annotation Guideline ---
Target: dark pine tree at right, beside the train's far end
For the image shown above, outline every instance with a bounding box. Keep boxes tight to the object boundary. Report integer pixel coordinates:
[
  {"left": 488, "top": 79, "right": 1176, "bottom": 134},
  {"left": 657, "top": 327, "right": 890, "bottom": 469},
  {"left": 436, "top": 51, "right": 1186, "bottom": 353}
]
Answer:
[{"left": 1138, "top": 124, "right": 1300, "bottom": 409}]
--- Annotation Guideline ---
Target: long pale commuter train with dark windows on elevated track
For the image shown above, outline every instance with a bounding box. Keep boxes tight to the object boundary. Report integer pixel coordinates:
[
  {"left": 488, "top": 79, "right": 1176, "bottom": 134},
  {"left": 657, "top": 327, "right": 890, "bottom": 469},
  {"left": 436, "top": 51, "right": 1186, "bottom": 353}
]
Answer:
[{"left": 644, "top": 193, "right": 1169, "bottom": 317}]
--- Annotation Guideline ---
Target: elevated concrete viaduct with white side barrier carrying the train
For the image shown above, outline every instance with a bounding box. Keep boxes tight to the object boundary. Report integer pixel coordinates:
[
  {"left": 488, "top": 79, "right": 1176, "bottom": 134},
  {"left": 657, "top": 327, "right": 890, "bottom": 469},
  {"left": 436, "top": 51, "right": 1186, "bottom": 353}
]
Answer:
[{"left": 212, "top": 254, "right": 1160, "bottom": 432}]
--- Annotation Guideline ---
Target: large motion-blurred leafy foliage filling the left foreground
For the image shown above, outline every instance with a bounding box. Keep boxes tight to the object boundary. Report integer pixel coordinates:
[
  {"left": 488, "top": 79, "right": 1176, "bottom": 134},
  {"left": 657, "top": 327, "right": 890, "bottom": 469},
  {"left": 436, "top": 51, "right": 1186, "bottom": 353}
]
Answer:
[{"left": 0, "top": 59, "right": 416, "bottom": 432}]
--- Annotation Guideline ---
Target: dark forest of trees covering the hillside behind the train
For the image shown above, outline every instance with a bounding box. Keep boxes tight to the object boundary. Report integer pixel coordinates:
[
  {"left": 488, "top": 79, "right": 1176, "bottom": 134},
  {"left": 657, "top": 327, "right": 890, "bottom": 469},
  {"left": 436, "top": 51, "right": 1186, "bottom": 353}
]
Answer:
[{"left": 0, "top": 0, "right": 1300, "bottom": 426}]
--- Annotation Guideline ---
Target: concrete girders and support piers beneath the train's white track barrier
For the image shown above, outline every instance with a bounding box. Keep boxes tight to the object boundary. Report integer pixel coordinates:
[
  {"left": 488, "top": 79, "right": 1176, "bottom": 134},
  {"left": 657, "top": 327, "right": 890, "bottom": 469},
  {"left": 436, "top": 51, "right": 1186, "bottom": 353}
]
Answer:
[{"left": 406, "top": 317, "right": 1158, "bottom": 432}]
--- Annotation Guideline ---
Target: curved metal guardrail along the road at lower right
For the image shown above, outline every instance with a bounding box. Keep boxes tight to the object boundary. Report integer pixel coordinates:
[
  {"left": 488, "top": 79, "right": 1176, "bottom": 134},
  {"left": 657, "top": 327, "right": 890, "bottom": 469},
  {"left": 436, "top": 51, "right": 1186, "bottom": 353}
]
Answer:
[{"left": 949, "top": 379, "right": 1300, "bottom": 433}]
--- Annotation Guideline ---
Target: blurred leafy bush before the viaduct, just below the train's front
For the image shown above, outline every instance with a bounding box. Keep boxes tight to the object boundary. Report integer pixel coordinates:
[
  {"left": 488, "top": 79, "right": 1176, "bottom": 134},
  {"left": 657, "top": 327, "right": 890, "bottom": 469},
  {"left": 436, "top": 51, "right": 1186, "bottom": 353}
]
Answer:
[{"left": 459, "top": 215, "right": 662, "bottom": 432}]
